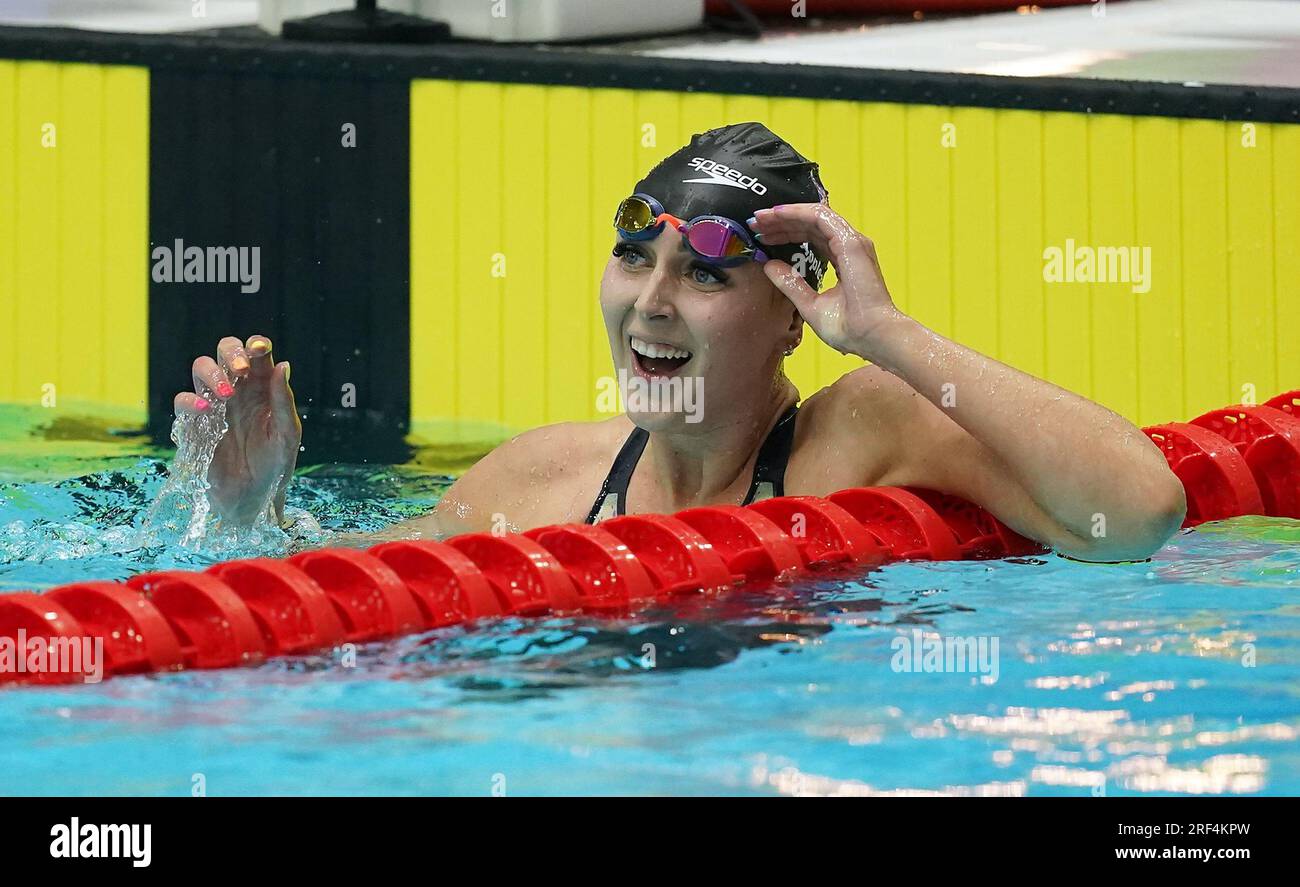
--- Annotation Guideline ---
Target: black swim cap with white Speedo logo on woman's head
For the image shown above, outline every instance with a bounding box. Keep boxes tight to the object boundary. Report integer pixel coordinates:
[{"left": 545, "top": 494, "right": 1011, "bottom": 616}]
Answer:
[{"left": 636, "top": 122, "right": 829, "bottom": 290}]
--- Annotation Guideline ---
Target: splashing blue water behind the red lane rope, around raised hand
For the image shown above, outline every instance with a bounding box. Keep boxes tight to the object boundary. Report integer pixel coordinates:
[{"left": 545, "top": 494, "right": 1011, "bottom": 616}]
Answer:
[{"left": 0, "top": 444, "right": 452, "bottom": 582}]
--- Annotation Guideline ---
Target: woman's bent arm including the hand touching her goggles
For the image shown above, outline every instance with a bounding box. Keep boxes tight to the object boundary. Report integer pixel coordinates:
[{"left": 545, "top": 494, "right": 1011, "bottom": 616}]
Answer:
[{"left": 750, "top": 203, "right": 1187, "bottom": 561}]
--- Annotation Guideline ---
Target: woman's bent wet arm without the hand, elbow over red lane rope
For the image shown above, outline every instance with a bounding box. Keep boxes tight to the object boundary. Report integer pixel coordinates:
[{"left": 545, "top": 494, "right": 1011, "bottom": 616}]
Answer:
[{"left": 855, "top": 312, "right": 1187, "bottom": 561}]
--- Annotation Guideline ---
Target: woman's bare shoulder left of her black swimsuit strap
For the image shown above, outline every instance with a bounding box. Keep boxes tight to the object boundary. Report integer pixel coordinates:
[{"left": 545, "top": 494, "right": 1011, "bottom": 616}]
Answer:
[{"left": 423, "top": 415, "right": 633, "bottom": 536}]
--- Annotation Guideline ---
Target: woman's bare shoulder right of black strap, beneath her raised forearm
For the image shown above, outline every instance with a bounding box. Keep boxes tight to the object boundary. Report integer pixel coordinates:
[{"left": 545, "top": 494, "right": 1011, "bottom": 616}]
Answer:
[{"left": 785, "top": 364, "right": 931, "bottom": 496}]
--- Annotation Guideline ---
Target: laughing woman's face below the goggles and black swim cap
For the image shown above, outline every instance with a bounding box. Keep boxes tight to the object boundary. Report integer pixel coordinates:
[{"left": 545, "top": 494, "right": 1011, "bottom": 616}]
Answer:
[{"left": 601, "top": 225, "right": 802, "bottom": 430}]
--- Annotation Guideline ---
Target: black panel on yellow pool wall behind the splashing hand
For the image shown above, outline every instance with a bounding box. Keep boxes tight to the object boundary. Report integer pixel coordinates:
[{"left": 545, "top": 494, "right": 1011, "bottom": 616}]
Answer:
[{"left": 150, "top": 69, "right": 411, "bottom": 464}]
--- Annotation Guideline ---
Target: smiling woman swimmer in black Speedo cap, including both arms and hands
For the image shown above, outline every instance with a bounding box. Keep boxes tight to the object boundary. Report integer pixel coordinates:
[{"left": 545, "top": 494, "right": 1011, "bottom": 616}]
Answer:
[{"left": 176, "top": 122, "right": 1186, "bottom": 561}]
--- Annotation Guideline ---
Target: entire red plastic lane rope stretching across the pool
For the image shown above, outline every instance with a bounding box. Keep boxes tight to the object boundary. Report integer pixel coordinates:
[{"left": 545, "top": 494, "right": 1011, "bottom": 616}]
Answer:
[{"left": 0, "top": 390, "right": 1300, "bottom": 684}]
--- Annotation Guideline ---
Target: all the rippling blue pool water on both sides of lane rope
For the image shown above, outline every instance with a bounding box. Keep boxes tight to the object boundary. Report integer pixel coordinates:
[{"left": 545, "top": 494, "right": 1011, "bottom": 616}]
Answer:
[{"left": 0, "top": 429, "right": 1300, "bottom": 796}]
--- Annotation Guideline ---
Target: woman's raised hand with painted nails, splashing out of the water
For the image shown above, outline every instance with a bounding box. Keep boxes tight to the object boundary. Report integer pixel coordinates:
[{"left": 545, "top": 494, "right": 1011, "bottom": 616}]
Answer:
[{"left": 173, "top": 336, "right": 303, "bottom": 525}]
